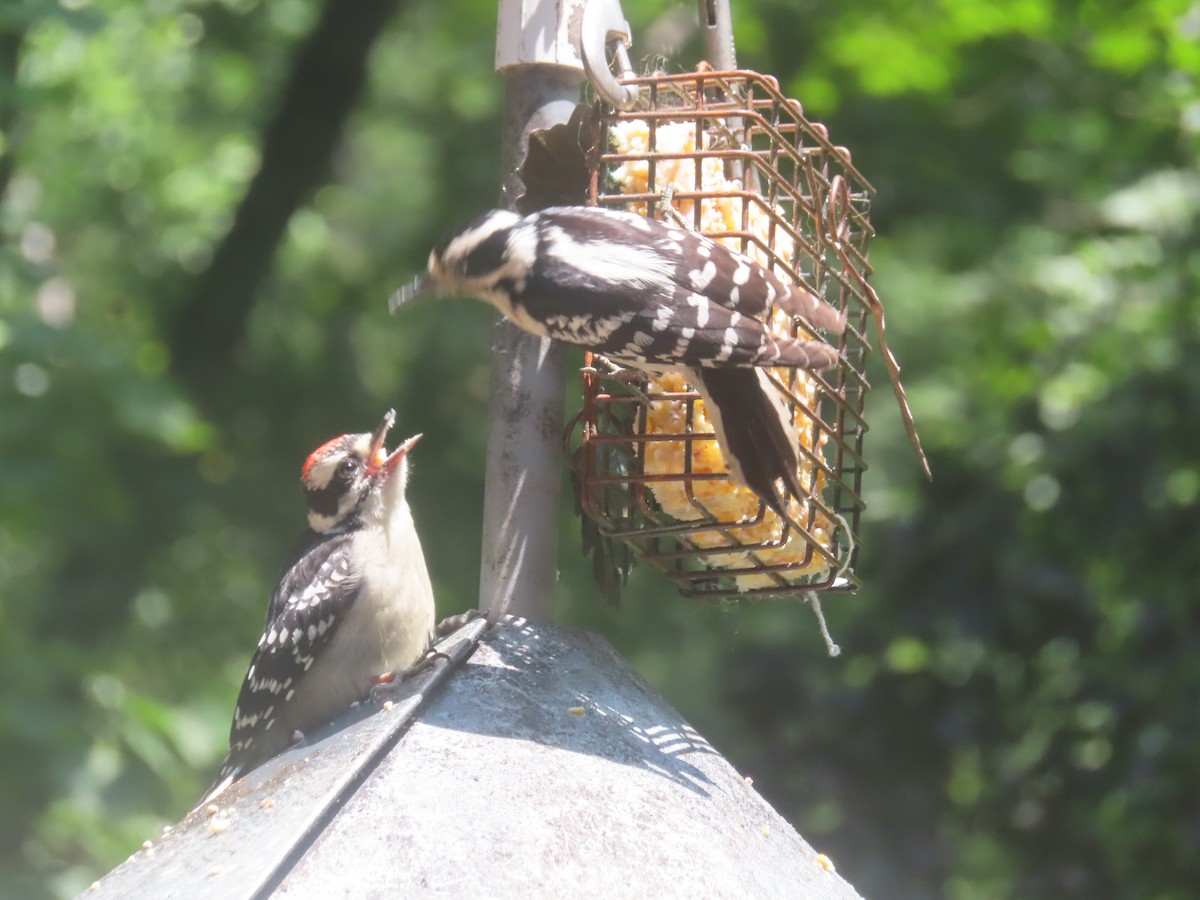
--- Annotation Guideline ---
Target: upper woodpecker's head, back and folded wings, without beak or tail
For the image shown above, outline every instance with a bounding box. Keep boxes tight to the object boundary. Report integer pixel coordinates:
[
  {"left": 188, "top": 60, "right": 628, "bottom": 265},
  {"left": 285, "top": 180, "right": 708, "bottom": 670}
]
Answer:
[{"left": 412, "top": 206, "right": 845, "bottom": 368}]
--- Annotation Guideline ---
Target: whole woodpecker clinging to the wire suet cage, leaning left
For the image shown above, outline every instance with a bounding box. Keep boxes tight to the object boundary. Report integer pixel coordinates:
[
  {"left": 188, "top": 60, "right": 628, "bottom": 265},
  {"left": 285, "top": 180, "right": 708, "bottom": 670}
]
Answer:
[{"left": 392, "top": 206, "right": 846, "bottom": 518}]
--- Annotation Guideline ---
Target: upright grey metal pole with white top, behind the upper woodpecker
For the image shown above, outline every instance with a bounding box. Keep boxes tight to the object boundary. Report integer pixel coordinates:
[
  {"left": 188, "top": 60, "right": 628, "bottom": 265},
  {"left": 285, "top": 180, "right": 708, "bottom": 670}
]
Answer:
[{"left": 479, "top": 0, "right": 583, "bottom": 622}]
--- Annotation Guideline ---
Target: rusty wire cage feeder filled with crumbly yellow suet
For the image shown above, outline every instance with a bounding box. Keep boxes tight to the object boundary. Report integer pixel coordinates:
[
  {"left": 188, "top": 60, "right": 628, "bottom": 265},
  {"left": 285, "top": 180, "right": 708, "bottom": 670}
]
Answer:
[{"left": 570, "top": 67, "right": 874, "bottom": 599}]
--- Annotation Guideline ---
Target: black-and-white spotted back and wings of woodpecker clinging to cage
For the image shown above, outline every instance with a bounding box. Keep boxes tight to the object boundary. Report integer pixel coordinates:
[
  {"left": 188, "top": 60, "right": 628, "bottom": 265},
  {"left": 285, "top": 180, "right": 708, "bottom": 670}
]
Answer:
[{"left": 514, "top": 206, "right": 845, "bottom": 368}]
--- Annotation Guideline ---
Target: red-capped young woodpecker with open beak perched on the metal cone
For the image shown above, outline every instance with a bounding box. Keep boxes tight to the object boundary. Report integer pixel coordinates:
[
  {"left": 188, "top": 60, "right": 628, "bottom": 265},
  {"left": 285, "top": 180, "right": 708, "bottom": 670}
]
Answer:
[{"left": 200, "top": 410, "right": 434, "bottom": 803}]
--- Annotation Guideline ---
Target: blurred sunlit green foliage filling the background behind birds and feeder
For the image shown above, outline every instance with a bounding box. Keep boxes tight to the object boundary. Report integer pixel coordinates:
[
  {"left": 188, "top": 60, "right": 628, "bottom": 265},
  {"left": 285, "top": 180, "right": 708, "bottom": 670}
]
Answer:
[{"left": 0, "top": 0, "right": 1200, "bottom": 900}]
